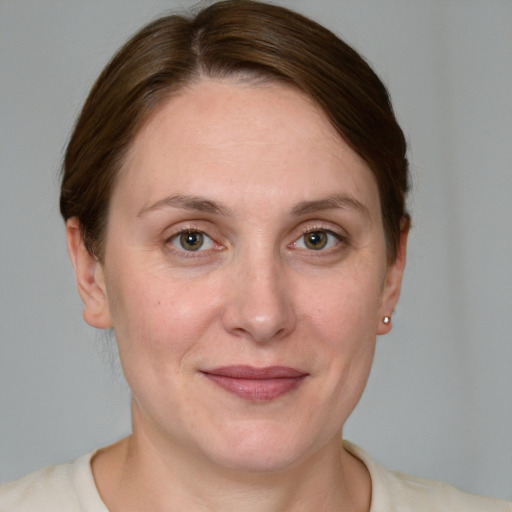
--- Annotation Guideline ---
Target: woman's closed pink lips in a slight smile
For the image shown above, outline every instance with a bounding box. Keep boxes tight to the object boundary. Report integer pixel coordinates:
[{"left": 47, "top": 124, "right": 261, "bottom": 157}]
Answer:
[{"left": 202, "top": 366, "right": 308, "bottom": 402}]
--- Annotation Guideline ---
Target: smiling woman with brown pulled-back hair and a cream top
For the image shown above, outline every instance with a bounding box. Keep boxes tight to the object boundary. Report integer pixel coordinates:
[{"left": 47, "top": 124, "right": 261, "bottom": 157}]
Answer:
[{"left": 0, "top": 1, "right": 511, "bottom": 511}]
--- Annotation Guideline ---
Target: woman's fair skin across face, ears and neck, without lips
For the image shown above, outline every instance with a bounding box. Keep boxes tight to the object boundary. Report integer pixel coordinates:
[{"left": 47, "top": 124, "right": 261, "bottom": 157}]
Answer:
[{"left": 67, "top": 80, "right": 407, "bottom": 512}]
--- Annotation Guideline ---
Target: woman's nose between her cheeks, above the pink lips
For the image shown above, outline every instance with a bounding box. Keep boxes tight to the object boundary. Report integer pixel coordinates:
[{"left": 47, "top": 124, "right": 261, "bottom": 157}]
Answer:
[{"left": 223, "top": 250, "right": 296, "bottom": 343}]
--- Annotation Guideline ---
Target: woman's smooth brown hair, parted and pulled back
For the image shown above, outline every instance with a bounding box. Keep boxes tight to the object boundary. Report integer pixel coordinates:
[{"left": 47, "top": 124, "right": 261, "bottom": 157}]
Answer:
[{"left": 60, "top": 0, "right": 409, "bottom": 261}]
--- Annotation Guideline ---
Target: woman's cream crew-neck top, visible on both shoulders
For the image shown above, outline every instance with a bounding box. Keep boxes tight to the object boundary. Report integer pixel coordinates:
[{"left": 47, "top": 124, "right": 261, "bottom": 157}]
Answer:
[{"left": 0, "top": 441, "right": 512, "bottom": 512}]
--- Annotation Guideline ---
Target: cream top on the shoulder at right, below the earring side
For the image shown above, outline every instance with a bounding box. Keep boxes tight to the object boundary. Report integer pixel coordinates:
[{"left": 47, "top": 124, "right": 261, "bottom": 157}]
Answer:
[{"left": 345, "top": 442, "right": 512, "bottom": 512}]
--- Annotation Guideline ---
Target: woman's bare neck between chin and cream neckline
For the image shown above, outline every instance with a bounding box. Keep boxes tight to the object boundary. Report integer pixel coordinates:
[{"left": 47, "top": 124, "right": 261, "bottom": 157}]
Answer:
[{"left": 92, "top": 406, "right": 371, "bottom": 512}]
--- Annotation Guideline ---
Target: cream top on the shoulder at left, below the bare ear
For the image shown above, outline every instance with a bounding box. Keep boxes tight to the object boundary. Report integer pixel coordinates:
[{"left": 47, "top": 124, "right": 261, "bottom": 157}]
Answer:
[{"left": 0, "top": 454, "right": 107, "bottom": 512}]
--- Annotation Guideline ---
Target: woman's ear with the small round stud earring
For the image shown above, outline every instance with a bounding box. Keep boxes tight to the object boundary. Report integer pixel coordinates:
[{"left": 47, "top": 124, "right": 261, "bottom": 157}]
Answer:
[{"left": 377, "top": 224, "right": 409, "bottom": 335}]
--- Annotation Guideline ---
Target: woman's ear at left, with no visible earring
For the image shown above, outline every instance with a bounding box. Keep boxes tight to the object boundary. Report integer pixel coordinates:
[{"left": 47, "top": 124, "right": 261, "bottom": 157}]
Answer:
[{"left": 66, "top": 217, "right": 112, "bottom": 329}]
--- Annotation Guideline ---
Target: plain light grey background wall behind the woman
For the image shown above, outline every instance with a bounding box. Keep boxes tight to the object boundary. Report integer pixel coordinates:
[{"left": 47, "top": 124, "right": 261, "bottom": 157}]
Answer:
[{"left": 0, "top": 0, "right": 512, "bottom": 499}]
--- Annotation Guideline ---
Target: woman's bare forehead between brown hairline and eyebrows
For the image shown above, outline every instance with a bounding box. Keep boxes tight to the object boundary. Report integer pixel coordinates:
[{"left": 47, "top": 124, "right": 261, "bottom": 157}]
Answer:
[{"left": 114, "top": 80, "right": 378, "bottom": 216}]
